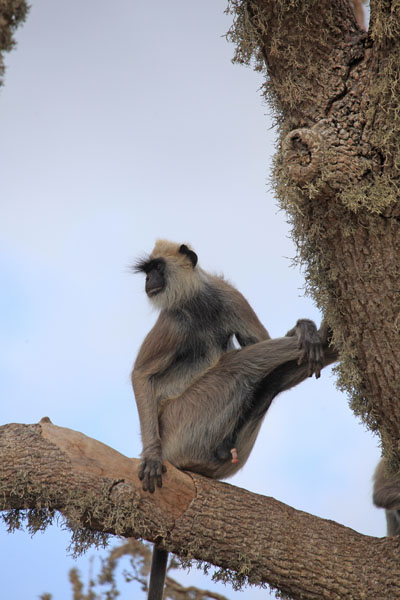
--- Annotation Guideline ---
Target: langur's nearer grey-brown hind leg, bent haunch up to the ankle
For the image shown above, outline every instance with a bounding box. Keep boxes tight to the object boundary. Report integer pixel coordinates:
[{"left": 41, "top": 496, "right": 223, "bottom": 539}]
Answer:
[{"left": 160, "top": 337, "right": 300, "bottom": 472}]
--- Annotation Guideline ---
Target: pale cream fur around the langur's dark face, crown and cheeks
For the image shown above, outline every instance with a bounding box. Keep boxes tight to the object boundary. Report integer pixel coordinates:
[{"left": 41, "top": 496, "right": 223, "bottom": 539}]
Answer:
[{"left": 150, "top": 240, "right": 204, "bottom": 309}]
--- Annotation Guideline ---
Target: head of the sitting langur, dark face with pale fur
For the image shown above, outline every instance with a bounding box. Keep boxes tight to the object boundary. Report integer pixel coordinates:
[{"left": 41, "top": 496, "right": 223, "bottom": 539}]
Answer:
[{"left": 134, "top": 240, "right": 201, "bottom": 309}]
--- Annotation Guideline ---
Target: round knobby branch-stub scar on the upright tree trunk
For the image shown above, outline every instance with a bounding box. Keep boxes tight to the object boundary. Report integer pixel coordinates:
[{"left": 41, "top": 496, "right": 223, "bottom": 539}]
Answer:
[{"left": 282, "top": 128, "right": 322, "bottom": 187}]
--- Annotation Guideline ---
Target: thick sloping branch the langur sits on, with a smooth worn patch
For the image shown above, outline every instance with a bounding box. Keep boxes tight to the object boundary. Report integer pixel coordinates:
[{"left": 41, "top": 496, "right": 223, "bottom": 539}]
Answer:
[{"left": 0, "top": 419, "right": 400, "bottom": 600}]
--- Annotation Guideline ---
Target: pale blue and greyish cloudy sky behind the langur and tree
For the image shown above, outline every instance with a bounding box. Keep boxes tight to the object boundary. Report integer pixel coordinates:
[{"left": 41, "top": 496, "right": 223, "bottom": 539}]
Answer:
[{"left": 0, "top": 0, "right": 385, "bottom": 600}]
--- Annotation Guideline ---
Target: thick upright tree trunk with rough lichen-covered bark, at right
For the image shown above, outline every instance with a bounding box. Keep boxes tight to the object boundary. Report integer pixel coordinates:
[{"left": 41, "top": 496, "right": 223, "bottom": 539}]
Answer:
[{"left": 230, "top": 0, "right": 400, "bottom": 468}]
